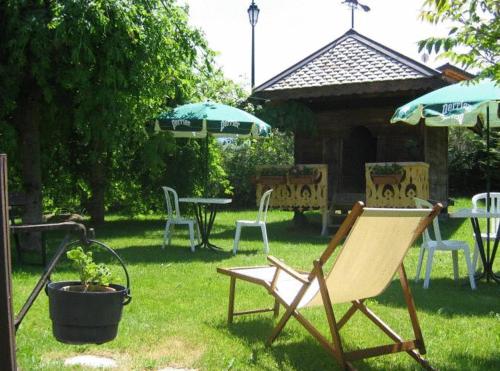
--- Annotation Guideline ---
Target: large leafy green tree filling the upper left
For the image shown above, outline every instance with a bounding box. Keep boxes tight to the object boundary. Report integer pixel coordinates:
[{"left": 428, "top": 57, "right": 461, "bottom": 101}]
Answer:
[{"left": 0, "top": 0, "right": 219, "bottom": 223}]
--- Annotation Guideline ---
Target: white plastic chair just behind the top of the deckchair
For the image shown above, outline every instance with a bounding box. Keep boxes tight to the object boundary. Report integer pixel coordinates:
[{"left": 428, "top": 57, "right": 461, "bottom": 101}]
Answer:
[{"left": 414, "top": 197, "right": 476, "bottom": 290}]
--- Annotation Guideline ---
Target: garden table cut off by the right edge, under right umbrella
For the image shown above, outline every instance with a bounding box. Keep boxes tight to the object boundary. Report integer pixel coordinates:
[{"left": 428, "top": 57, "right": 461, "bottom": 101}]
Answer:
[{"left": 450, "top": 208, "right": 500, "bottom": 282}]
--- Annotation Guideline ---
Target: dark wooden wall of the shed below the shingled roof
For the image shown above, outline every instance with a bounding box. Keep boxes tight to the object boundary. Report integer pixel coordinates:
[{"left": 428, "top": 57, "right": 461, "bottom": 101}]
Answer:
[{"left": 295, "top": 98, "right": 448, "bottom": 205}]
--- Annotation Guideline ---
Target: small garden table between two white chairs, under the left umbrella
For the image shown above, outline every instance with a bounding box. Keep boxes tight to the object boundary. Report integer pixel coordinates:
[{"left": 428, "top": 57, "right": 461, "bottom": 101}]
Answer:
[{"left": 179, "top": 197, "right": 233, "bottom": 251}]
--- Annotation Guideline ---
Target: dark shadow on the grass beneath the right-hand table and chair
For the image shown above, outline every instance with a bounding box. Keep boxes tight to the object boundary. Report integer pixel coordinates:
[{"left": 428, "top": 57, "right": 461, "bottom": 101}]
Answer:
[{"left": 376, "top": 278, "right": 500, "bottom": 317}]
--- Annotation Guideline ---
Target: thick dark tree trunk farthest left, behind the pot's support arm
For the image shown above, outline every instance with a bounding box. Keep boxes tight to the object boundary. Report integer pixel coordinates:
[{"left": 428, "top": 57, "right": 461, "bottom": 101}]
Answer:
[{"left": 14, "top": 80, "right": 42, "bottom": 250}]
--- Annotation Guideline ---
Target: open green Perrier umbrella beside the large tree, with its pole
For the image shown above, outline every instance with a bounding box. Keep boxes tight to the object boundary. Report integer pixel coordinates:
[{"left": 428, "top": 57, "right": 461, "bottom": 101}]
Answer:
[{"left": 155, "top": 102, "right": 271, "bottom": 195}]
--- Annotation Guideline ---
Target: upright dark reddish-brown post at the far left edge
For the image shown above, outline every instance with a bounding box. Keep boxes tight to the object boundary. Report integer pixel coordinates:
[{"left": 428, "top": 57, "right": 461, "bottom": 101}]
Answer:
[{"left": 0, "top": 154, "right": 17, "bottom": 370}]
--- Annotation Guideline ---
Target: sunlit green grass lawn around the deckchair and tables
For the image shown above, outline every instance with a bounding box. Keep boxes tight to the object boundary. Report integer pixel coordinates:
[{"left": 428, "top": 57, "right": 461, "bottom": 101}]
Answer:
[{"left": 9, "top": 200, "right": 500, "bottom": 371}]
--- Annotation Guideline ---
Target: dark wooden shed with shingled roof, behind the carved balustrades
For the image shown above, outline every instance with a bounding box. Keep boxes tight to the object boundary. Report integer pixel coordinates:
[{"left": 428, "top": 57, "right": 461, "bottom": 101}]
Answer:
[{"left": 252, "top": 29, "right": 470, "bottom": 212}]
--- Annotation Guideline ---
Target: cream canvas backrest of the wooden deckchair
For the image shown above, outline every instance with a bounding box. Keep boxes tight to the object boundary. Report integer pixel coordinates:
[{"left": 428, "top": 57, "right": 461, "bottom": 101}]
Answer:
[{"left": 308, "top": 208, "right": 431, "bottom": 305}]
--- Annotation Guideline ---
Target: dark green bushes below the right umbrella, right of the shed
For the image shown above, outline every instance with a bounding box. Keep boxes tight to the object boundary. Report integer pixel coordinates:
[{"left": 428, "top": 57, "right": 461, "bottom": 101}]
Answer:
[{"left": 448, "top": 127, "right": 500, "bottom": 194}]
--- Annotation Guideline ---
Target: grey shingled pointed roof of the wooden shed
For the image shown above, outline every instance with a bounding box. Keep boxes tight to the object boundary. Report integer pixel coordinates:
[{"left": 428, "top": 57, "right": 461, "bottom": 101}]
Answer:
[{"left": 254, "top": 29, "right": 441, "bottom": 93}]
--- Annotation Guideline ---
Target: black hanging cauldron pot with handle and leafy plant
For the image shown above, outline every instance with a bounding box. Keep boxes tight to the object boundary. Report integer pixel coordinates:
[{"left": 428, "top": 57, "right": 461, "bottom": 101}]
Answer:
[{"left": 46, "top": 240, "right": 131, "bottom": 344}]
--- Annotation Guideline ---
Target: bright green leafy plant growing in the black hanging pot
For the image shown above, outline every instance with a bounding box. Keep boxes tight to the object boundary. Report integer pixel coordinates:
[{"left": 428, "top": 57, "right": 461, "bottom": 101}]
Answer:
[{"left": 66, "top": 246, "right": 111, "bottom": 291}]
